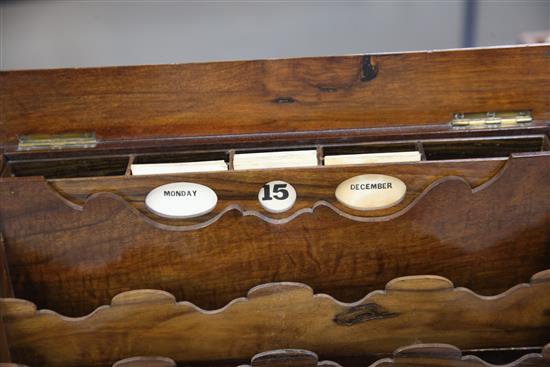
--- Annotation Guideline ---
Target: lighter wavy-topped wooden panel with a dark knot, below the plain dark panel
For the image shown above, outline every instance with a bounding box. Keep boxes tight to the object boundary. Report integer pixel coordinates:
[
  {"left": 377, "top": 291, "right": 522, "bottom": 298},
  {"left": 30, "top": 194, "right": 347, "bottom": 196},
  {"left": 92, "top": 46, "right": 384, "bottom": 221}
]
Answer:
[{"left": 0, "top": 276, "right": 550, "bottom": 367}]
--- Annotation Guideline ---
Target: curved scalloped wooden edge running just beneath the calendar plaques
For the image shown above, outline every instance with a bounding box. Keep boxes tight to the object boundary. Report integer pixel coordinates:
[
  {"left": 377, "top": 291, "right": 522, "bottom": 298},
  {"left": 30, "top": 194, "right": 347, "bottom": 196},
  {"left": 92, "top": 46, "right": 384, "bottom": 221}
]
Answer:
[{"left": 30, "top": 155, "right": 536, "bottom": 232}]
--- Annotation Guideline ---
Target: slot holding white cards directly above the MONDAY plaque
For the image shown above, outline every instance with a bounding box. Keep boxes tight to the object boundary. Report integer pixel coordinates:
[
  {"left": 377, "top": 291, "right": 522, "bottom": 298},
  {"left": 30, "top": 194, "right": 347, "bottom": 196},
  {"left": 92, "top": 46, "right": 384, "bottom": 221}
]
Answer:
[{"left": 130, "top": 151, "right": 229, "bottom": 176}]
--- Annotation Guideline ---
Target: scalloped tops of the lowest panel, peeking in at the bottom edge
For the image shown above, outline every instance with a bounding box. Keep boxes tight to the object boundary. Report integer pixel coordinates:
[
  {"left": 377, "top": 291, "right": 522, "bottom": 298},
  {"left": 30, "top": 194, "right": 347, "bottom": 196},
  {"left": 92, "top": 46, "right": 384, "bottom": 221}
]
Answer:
[{"left": 109, "top": 343, "right": 550, "bottom": 367}]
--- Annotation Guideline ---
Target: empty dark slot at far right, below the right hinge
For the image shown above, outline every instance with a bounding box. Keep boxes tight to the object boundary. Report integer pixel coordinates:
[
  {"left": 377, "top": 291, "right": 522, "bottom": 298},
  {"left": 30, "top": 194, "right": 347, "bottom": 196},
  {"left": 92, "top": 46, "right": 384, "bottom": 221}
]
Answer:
[{"left": 422, "top": 136, "right": 544, "bottom": 161}]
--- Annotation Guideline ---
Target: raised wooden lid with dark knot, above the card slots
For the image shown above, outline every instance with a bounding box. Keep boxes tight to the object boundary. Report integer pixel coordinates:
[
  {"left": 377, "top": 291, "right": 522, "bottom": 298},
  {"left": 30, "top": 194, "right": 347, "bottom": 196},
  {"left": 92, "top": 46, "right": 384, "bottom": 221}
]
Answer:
[{"left": 0, "top": 45, "right": 550, "bottom": 144}]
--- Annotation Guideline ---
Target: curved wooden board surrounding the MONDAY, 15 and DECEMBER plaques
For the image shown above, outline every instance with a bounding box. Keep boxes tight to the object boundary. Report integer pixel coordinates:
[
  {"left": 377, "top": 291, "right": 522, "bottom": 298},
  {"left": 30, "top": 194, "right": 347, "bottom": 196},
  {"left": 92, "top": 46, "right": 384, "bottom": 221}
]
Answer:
[{"left": 4, "top": 157, "right": 508, "bottom": 231}]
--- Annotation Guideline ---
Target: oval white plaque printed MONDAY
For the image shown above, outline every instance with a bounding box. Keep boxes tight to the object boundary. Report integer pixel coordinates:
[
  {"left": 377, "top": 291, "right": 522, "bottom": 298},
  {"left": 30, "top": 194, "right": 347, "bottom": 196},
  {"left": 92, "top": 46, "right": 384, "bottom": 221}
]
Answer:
[{"left": 145, "top": 182, "right": 218, "bottom": 218}]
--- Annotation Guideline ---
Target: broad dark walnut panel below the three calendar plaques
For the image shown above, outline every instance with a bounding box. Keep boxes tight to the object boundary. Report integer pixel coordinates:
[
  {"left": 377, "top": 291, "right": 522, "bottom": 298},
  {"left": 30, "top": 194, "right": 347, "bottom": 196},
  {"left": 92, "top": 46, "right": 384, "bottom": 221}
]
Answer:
[{"left": 0, "top": 153, "right": 550, "bottom": 316}]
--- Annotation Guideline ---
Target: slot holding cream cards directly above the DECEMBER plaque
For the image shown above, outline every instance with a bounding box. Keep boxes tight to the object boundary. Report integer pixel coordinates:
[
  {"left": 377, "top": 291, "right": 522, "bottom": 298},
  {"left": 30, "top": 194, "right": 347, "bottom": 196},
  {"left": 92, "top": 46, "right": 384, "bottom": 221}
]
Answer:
[{"left": 323, "top": 143, "right": 422, "bottom": 166}]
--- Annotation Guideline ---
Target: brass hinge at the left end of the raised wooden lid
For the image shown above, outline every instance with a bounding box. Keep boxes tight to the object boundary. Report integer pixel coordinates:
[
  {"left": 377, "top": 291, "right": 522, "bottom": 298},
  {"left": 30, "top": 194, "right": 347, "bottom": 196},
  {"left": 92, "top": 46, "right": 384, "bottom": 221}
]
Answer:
[{"left": 17, "top": 132, "right": 97, "bottom": 150}]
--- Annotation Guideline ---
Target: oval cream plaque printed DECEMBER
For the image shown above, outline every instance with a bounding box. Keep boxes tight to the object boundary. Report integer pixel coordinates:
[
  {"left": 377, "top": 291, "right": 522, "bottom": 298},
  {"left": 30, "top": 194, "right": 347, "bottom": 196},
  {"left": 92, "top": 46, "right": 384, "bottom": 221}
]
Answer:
[{"left": 336, "top": 174, "right": 407, "bottom": 210}]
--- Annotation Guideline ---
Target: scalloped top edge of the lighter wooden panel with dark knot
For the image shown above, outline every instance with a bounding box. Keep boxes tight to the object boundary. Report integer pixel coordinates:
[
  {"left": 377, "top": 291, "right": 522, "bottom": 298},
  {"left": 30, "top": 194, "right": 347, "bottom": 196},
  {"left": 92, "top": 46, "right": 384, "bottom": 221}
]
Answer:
[{"left": 0, "top": 269, "right": 550, "bottom": 321}]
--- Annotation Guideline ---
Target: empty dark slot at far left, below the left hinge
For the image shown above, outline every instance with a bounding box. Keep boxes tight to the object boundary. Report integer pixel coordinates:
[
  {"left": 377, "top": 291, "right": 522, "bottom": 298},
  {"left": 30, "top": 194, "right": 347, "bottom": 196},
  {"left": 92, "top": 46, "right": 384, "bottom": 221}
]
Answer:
[{"left": 8, "top": 156, "right": 128, "bottom": 178}]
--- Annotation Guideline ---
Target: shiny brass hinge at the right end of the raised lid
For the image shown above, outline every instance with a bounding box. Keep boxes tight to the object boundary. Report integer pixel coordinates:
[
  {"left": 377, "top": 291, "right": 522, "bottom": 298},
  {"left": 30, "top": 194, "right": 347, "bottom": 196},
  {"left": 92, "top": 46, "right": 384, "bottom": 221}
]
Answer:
[{"left": 451, "top": 111, "right": 533, "bottom": 129}]
